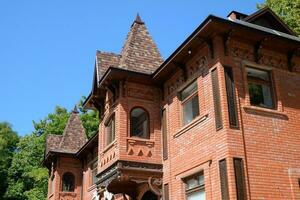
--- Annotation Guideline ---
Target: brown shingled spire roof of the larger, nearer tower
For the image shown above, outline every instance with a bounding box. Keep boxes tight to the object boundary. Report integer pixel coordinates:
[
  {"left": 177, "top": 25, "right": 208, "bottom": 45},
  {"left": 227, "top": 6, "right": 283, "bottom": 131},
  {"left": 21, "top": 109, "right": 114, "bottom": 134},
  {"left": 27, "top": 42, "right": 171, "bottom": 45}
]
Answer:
[{"left": 96, "top": 15, "right": 163, "bottom": 81}]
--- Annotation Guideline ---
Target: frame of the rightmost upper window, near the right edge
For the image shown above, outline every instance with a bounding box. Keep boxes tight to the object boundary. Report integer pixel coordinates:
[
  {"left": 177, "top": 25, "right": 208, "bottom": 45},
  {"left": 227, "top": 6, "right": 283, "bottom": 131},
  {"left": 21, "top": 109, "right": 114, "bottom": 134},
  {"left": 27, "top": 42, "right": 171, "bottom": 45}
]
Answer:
[{"left": 245, "top": 65, "right": 278, "bottom": 110}]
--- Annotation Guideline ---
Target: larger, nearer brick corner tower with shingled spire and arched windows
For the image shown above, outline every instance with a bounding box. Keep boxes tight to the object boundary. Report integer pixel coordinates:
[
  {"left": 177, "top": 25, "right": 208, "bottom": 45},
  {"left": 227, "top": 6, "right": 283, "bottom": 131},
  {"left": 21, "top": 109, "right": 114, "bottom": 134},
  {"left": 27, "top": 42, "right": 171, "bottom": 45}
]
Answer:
[{"left": 84, "top": 15, "right": 163, "bottom": 199}]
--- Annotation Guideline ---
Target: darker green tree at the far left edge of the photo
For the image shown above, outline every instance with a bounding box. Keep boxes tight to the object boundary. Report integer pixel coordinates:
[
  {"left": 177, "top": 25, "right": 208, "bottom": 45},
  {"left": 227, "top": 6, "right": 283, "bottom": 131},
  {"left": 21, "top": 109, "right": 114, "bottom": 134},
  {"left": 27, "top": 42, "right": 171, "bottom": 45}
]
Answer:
[{"left": 0, "top": 122, "right": 19, "bottom": 199}]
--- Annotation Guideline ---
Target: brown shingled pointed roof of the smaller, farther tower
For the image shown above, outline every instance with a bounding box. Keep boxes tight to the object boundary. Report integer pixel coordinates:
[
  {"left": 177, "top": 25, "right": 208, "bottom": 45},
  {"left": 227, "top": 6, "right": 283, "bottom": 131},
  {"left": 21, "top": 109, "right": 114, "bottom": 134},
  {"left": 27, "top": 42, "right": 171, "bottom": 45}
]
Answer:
[{"left": 45, "top": 108, "right": 87, "bottom": 155}]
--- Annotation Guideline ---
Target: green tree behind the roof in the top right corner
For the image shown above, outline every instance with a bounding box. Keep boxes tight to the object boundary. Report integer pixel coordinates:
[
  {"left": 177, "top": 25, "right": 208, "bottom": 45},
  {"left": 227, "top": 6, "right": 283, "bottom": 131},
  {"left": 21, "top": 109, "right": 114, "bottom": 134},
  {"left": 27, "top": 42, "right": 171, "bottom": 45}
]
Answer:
[{"left": 257, "top": 0, "right": 300, "bottom": 36}]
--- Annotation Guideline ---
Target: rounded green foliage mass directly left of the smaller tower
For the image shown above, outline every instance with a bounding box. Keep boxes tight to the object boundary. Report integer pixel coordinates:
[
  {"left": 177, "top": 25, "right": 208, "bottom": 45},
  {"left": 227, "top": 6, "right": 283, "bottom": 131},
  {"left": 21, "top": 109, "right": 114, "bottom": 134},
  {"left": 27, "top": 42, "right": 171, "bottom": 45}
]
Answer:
[{"left": 5, "top": 134, "right": 48, "bottom": 200}]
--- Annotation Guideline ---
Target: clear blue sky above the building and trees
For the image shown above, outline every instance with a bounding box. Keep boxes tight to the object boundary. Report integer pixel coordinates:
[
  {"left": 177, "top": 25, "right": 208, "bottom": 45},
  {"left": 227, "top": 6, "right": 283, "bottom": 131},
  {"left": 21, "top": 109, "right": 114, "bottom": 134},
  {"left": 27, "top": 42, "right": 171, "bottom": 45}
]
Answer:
[{"left": 0, "top": 0, "right": 261, "bottom": 135}]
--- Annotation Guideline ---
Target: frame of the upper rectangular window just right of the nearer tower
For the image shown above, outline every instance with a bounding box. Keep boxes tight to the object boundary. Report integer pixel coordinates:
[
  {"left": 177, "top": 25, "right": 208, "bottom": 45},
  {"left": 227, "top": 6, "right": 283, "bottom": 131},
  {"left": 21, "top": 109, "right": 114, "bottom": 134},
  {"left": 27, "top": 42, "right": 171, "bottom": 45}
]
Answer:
[{"left": 178, "top": 79, "right": 200, "bottom": 126}]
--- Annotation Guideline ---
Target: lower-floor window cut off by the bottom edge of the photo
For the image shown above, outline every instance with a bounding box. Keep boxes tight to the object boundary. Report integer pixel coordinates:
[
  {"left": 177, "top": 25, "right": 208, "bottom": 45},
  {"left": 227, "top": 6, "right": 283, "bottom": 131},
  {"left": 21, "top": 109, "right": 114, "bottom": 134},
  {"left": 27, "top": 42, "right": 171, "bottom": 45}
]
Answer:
[{"left": 185, "top": 173, "right": 205, "bottom": 200}]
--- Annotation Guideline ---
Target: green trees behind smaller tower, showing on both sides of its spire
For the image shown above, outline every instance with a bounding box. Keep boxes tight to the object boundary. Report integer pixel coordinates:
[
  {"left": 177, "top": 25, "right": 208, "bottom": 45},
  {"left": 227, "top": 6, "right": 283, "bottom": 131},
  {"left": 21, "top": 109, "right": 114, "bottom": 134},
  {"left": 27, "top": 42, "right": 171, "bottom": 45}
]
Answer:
[{"left": 4, "top": 97, "right": 99, "bottom": 200}]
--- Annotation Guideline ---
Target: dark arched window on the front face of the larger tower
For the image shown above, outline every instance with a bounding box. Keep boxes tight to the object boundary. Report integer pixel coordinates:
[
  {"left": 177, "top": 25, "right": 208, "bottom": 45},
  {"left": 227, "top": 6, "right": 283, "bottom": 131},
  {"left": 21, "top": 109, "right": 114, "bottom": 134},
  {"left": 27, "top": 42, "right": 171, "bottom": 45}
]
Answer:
[{"left": 130, "top": 108, "right": 149, "bottom": 138}]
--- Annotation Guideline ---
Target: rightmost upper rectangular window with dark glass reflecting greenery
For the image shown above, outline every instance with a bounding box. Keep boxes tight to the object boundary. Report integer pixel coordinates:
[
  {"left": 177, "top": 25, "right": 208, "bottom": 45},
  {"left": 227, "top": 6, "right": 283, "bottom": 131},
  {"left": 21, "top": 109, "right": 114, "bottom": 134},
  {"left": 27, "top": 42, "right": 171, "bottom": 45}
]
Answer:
[{"left": 246, "top": 67, "right": 274, "bottom": 108}]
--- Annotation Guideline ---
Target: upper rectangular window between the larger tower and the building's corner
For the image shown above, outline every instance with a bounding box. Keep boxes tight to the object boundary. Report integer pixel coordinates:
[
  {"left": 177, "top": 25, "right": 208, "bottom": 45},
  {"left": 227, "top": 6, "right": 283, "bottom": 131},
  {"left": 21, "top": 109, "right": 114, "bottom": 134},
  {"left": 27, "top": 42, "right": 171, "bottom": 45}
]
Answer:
[{"left": 180, "top": 81, "right": 199, "bottom": 125}]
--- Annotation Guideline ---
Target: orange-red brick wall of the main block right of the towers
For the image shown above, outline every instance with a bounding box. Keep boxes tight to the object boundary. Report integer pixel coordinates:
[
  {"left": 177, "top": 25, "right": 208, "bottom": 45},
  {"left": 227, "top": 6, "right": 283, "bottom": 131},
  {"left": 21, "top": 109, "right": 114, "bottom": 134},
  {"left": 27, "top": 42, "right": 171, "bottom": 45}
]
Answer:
[{"left": 163, "top": 36, "right": 300, "bottom": 200}]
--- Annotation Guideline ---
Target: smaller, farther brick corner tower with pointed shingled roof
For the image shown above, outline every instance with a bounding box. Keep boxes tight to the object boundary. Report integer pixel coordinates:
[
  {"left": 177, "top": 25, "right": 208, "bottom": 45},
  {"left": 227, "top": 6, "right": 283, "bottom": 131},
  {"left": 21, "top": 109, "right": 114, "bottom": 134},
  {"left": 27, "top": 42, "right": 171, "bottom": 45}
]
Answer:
[{"left": 44, "top": 107, "right": 87, "bottom": 200}]
